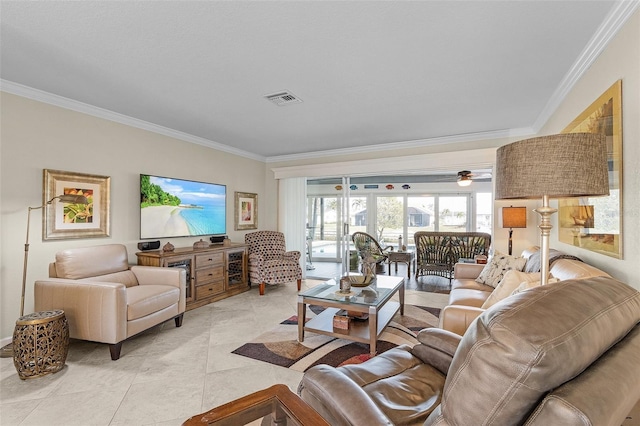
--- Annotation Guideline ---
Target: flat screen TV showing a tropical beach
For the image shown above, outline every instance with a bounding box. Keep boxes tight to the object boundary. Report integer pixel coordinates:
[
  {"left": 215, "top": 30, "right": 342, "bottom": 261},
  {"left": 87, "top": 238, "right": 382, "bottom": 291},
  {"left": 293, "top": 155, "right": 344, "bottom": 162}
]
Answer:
[{"left": 140, "top": 174, "right": 227, "bottom": 239}]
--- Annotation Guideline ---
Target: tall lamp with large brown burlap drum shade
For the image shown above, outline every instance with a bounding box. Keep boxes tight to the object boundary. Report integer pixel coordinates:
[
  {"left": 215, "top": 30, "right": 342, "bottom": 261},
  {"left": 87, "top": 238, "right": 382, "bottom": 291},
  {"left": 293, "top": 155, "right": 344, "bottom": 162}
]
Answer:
[{"left": 495, "top": 133, "right": 609, "bottom": 285}]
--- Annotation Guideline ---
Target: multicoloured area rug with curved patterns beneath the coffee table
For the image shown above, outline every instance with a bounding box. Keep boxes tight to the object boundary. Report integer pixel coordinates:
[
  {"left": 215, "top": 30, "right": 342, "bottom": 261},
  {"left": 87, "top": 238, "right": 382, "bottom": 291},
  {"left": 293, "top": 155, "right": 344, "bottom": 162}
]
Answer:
[{"left": 232, "top": 304, "right": 440, "bottom": 372}]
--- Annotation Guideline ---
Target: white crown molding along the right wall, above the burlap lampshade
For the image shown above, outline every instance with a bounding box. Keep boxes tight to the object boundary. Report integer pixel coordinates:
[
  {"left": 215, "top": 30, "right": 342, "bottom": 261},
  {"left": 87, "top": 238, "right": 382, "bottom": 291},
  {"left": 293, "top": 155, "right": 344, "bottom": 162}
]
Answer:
[{"left": 532, "top": 0, "right": 640, "bottom": 133}]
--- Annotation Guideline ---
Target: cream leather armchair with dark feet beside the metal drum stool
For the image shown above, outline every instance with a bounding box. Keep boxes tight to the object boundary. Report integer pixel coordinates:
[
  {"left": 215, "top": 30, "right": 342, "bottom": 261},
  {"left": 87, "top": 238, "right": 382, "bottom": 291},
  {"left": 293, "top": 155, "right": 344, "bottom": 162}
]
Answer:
[{"left": 35, "top": 244, "right": 186, "bottom": 361}]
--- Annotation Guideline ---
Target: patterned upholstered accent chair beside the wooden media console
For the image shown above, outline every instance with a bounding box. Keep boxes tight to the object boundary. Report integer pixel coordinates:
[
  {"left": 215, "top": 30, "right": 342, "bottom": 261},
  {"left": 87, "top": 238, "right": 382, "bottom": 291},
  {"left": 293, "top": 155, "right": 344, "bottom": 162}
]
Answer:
[{"left": 244, "top": 231, "right": 302, "bottom": 296}]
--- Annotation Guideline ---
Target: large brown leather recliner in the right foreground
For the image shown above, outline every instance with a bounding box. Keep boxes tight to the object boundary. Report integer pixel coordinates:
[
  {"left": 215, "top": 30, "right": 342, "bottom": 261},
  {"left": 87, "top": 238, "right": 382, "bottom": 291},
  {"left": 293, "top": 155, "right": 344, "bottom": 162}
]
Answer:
[{"left": 298, "top": 277, "right": 640, "bottom": 426}]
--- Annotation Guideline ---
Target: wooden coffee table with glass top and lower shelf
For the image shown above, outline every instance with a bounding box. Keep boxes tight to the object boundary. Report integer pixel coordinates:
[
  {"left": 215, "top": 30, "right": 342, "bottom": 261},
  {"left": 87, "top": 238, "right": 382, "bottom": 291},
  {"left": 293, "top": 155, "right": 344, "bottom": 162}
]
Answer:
[{"left": 298, "top": 275, "right": 404, "bottom": 356}]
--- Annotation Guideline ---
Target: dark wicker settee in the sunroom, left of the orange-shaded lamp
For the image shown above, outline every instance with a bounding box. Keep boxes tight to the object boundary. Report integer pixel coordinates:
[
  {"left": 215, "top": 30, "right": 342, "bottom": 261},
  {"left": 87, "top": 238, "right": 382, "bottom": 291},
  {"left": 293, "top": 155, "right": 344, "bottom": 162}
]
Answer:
[{"left": 414, "top": 231, "right": 491, "bottom": 284}]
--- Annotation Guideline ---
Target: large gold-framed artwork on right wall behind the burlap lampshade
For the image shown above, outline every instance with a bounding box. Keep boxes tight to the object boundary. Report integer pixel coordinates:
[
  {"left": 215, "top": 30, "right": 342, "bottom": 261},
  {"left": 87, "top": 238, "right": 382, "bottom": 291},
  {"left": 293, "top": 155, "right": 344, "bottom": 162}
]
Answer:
[{"left": 558, "top": 80, "right": 622, "bottom": 259}]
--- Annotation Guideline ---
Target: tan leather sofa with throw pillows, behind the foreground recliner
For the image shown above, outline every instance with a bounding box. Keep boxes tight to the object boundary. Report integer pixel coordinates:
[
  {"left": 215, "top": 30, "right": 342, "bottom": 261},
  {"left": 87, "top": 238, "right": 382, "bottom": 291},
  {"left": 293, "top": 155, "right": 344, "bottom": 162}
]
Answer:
[{"left": 440, "top": 246, "right": 609, "bottom": 335}]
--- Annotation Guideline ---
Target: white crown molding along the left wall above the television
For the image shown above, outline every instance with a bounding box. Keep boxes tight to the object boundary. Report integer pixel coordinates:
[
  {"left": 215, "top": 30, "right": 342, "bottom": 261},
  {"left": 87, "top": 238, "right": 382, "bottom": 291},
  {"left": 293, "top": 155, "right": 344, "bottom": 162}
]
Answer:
[{"left": 0, "top": 79, "right": 265, "bottom": 162}]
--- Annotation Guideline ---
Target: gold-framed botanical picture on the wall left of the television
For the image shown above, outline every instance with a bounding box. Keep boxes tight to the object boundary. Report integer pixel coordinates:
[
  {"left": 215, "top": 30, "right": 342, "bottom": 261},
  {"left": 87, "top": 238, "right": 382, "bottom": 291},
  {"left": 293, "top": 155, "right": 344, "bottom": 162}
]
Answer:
[{"left": 42, "top": 169, "right": 111, "bottom": 240}]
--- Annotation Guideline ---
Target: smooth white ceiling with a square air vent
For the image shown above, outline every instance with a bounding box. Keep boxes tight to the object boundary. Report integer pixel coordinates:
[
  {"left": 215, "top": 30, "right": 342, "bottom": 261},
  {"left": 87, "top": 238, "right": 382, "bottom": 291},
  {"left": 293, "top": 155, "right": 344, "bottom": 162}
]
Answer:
[{"left": 0, "top": 0, "right": 637, "bottom": 161}]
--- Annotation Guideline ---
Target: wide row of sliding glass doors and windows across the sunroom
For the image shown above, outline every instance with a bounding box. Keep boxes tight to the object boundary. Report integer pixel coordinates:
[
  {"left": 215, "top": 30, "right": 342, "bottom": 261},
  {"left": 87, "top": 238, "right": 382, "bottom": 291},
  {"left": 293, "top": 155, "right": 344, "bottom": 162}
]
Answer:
[{"left": 306, "top": 178, "right": 492, "bottom": 264}]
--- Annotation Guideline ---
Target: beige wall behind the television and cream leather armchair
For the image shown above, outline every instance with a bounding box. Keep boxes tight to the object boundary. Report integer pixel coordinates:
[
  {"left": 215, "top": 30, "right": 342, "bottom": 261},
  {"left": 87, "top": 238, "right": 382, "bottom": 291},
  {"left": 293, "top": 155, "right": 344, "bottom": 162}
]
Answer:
[{"left": 0, "top": 92, "right": 277, "bottom": 338}]
